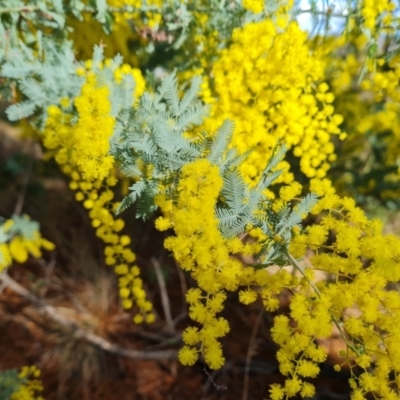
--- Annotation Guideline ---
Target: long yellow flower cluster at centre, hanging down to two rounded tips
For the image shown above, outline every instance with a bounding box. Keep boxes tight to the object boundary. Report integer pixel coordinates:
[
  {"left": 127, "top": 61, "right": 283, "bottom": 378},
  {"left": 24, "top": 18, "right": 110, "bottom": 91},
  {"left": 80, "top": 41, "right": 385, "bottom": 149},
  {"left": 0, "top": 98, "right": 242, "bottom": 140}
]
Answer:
[{"left": 155, "top": 159, "right": 242, "bottom": 369}]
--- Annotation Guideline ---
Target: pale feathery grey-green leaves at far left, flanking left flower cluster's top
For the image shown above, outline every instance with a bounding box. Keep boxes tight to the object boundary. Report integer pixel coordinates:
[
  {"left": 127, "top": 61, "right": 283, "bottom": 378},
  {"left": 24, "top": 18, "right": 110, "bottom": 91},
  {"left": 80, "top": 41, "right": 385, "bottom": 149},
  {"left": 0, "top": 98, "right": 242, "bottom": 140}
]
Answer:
[{"left": 0, "top": 40, "right": 139, "bottom": 129}]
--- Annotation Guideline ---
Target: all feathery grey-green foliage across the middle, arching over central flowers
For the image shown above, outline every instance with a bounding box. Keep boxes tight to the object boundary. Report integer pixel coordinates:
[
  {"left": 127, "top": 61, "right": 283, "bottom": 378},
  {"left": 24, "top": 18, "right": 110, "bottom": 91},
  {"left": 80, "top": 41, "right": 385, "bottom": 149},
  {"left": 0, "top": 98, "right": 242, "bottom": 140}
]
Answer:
[{"left": 113, "top": 74, "right": 317, "bottom": 264}]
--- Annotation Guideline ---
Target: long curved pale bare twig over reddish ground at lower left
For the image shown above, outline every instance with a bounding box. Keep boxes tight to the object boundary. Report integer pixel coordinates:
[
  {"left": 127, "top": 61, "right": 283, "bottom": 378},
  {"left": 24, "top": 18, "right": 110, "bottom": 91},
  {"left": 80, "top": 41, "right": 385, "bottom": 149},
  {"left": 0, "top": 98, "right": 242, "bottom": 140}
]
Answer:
[{"left": 0, "top": 271, "right": 177, "bottom": 360}]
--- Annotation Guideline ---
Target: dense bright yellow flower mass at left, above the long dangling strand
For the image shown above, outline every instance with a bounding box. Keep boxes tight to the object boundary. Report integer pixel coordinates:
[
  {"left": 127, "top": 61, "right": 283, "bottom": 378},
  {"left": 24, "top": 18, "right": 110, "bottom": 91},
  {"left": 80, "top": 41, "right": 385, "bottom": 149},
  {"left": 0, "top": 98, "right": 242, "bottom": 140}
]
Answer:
[{"left": 44, "top": 55, "right": 144, "bottom": 181}]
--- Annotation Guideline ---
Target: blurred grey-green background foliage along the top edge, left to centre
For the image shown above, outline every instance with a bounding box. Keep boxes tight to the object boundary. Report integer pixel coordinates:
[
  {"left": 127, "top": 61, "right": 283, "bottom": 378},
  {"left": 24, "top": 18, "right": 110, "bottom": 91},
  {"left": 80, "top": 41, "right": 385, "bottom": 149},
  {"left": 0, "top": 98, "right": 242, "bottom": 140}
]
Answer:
[{"left": 0, "top": 0, "right": 245, "bottom": 79}]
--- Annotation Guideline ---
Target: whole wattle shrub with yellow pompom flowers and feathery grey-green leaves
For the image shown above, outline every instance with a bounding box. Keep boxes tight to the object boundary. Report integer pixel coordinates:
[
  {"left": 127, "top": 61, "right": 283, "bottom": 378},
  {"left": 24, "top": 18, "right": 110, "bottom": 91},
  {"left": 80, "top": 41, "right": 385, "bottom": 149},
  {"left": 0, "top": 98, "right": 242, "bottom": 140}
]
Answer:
[{"left": 0, "top": 0, "right": 400, "bottom": 400}]
